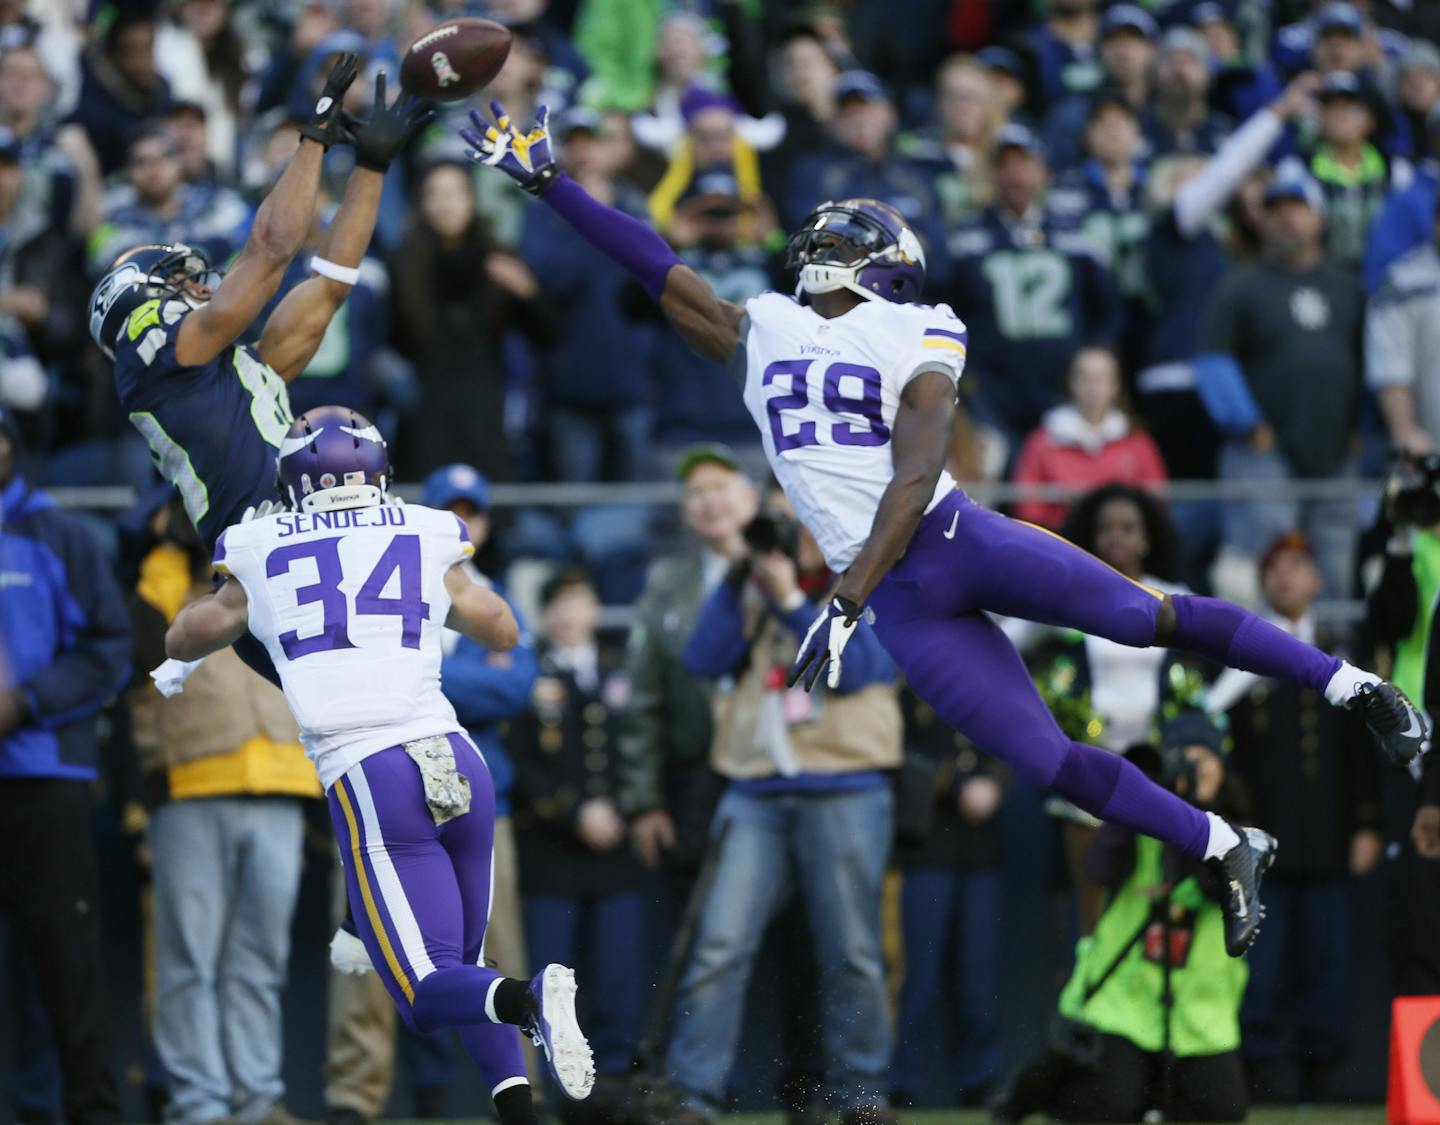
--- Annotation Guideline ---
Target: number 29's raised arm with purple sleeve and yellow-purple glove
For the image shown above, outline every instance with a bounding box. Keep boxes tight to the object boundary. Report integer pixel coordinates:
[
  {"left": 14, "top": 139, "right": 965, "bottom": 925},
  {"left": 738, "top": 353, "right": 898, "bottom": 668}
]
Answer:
[{"left": 461, "top": 102, "right": 744, "bottom": 363}]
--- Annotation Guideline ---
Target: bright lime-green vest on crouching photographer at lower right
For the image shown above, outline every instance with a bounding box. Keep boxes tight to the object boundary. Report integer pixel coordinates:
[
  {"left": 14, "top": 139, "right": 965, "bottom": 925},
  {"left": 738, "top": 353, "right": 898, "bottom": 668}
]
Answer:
[{"left": 1060, "top": 835, "right": 1250, "bottom": 1059}]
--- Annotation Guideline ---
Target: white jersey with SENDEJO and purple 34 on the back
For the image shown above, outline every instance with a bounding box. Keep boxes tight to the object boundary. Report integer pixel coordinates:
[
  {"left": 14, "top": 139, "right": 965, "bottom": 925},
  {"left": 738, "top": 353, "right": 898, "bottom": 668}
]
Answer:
[{"left": 215, "top": 504, "right": 474, "bottom": 789}]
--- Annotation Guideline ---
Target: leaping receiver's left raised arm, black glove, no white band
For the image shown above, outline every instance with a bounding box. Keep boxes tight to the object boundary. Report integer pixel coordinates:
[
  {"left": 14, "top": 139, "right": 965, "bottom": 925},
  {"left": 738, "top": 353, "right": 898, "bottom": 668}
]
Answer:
[{"left": 176, "top": 55, "right": 359, "bottom": 366}]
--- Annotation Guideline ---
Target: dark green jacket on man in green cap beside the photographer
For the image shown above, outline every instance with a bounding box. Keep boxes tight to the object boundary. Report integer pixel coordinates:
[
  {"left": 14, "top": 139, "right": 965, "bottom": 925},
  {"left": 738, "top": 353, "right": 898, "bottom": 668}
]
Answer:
[{"left": 619, "top": 556, "right": 713, "bottom": 817}]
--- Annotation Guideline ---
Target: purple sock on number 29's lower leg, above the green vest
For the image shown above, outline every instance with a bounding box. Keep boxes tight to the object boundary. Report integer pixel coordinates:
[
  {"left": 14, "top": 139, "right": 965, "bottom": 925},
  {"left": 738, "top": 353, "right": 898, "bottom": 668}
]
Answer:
[{"left": 1050, "top": 742, "right": 1210, "bottom": 859}]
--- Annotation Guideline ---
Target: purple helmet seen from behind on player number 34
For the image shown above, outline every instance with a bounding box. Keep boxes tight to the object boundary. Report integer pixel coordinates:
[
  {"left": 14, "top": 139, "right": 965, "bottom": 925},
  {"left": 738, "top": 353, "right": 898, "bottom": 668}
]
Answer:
[{"left": 275, "top": 406, "right": 390, "bottom": 511}]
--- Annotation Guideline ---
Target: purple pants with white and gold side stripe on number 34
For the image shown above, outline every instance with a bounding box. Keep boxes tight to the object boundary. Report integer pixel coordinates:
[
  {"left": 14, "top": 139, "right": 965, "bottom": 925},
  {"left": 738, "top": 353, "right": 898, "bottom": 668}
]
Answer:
[{"left": 328, "top": 735, "right": 527, "bottom": 1095}]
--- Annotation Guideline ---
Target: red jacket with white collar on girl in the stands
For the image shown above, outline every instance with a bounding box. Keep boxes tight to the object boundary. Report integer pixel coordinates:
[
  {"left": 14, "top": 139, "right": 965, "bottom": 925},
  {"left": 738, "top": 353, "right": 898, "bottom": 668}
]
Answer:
[{"left": 1015, "top": 406, "right": 1169, "bottom": 529}]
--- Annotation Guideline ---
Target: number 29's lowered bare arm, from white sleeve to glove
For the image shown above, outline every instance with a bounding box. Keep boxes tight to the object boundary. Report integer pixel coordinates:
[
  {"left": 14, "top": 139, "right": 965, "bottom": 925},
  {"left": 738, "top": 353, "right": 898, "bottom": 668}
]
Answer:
[{"left": 835, "top": 372, "right": 955, "bottom": 605}]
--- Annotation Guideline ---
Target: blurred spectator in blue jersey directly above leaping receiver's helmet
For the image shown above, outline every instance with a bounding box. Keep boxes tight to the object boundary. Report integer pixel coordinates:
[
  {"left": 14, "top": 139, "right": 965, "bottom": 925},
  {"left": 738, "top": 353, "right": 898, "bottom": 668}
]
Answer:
[{"left": 89, "top": 125, "right": 252, "bottom": 274}]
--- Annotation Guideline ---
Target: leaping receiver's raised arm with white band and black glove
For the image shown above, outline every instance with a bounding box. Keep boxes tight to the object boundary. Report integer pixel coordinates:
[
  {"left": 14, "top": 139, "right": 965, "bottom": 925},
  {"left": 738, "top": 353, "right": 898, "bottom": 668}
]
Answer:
[{"left": 260, "top": 72, "right": 433, "bottom": 383}]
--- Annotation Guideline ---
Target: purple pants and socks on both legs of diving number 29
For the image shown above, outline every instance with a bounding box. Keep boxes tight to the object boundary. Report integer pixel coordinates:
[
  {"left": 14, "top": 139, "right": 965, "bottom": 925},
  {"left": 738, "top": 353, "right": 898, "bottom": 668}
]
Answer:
[{"left": 870, "top": 490, "right": 1339, "bottom": 857}]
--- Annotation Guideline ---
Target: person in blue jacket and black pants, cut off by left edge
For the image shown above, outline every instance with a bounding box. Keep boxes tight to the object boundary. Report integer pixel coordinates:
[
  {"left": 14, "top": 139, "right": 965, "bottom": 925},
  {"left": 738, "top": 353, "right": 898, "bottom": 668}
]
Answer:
[{"left": 0, "top": 408, "right": 130, "bottom": 1125}]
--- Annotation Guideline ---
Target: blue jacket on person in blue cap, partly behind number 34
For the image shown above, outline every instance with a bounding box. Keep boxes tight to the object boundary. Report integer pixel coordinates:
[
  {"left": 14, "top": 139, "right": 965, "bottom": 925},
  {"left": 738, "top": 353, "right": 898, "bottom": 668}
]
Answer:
[{"left": 441, "top": 587, "right": 537, "bottom": 817}]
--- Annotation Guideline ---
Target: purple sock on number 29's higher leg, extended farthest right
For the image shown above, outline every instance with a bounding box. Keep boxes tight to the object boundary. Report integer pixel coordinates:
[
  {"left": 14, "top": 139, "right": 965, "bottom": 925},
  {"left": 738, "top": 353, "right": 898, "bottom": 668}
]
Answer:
[{"left": 1171, "top": 595, "right": 1341, "bottom": 694}]
